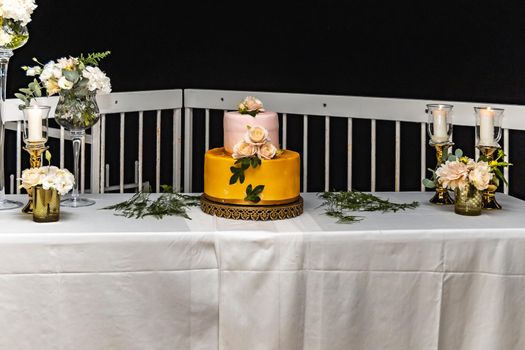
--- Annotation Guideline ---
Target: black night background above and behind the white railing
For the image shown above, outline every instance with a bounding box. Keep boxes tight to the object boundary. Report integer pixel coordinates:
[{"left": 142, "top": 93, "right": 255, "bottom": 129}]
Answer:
[{"left": 8, "top": 0, "right": 525, "bottom": 198}]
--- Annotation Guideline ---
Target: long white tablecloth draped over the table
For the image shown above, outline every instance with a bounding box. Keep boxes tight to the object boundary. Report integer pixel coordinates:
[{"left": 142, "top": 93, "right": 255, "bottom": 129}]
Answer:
[{"left": 0, "top": 192, "right": 525, "bottom": 350}]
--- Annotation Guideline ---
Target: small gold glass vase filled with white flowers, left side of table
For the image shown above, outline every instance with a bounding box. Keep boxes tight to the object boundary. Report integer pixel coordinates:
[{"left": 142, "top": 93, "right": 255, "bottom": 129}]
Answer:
[{"left": 20, "top": 158, "right": 74, "bottom": 222}]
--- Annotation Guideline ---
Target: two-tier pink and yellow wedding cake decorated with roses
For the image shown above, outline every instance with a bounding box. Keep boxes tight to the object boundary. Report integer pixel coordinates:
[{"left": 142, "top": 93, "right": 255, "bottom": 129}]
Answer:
[{"left": 203, "top": 96, "right": 302, "bottom": 219}]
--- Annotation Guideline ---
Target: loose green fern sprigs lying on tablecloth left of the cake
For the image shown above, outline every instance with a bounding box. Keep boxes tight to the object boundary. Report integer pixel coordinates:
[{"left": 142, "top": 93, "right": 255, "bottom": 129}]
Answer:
[{"left": 102, "top": 185, "right": 200, "bottom": 220}]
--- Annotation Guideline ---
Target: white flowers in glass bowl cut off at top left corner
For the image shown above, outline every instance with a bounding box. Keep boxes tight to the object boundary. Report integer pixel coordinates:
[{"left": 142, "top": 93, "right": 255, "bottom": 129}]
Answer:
[{"left": 0, "top": 0, "right": 37, "bottom": 49}]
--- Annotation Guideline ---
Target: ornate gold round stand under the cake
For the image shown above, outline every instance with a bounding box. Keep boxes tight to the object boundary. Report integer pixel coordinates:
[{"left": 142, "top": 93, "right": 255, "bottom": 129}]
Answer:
[{"left": 201, "top": 195, "right": 303, "bottom": 221}]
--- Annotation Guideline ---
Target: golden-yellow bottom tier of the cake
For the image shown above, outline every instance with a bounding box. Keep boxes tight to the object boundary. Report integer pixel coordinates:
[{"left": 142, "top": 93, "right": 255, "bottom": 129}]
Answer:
[{"left": 204, "top": 148, "right": 301, "bottom": 205}]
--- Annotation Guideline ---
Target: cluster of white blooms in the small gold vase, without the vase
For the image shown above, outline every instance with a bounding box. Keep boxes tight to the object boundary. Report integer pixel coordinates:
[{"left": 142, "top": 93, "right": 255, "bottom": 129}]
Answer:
[{"left": 20, "top": 165, "right": 75, "bottom": 195}]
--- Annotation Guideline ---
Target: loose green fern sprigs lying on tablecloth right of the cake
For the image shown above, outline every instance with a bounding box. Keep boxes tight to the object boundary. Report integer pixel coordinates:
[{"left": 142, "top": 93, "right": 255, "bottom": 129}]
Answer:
[{"left": 317, "top": 191, "right": 419, "bottom": 223}]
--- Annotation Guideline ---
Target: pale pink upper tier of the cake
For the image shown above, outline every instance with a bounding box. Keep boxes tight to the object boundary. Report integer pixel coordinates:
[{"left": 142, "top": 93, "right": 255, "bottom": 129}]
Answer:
[{"left": 224, "top": 111, "right": 279, "bottom": 153}]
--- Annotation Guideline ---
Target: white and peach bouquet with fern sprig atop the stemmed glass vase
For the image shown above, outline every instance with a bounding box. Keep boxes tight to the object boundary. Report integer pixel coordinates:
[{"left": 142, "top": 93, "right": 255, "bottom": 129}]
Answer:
[{"left": 15, "top": 51, "right": 111, "bottom": 106}]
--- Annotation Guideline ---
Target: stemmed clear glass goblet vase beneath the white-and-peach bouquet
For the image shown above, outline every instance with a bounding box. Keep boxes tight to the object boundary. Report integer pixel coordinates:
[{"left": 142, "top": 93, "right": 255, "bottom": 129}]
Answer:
[{"left": 55, "top": 90, "right": 100, "bottom": 208}]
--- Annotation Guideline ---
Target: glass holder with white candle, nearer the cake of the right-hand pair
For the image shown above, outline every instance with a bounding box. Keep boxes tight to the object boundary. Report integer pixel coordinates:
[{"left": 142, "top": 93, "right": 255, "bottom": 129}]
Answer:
[{"left": 426, "top": 104, "right": 454, "bottom": 145}]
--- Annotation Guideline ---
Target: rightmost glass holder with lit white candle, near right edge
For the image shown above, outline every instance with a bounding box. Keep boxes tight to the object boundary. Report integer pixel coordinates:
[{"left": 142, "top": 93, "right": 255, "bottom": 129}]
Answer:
[{"left": 474, "top": 107, "right": 504, "bottom": 147}]
